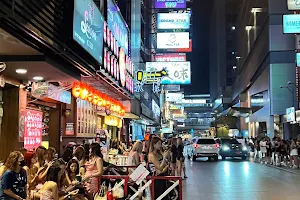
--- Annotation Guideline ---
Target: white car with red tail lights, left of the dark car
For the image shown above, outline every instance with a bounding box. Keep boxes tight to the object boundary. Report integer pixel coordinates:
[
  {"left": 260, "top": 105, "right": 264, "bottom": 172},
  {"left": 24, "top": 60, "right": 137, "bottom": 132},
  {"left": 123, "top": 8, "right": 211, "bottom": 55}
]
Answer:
[{"left": 192, "top": 138, "right": 219, "bottom": 161}]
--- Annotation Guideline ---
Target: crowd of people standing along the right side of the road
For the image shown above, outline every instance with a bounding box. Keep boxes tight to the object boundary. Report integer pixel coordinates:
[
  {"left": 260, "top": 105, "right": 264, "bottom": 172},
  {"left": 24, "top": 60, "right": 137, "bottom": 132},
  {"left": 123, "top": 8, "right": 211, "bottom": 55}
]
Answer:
[{"left": 248, "top": 136, "right": 300, "bottom": 169}]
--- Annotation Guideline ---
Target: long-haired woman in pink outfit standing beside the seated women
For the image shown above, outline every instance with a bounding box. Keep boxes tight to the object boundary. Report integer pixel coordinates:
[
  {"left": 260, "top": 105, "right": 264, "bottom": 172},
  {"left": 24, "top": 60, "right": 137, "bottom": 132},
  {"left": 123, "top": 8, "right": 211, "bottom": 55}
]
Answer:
[{"left": 83, "top": 143, "right": 103, "bottom": 199}]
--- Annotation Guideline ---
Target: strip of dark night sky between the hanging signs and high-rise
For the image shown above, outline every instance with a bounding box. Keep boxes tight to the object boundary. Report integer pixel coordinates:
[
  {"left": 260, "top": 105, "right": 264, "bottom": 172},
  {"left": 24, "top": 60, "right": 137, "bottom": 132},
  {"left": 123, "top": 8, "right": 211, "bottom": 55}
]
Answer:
[{"left": 184, "top": 0, "right": 212, "bottom": 94}]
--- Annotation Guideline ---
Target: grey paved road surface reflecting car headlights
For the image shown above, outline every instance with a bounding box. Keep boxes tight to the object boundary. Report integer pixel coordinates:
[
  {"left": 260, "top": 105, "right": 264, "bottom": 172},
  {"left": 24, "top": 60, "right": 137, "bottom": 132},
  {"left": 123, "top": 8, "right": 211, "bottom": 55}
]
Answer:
[{"left": 183, "top": 159, "right": 300, "bottom": 200}]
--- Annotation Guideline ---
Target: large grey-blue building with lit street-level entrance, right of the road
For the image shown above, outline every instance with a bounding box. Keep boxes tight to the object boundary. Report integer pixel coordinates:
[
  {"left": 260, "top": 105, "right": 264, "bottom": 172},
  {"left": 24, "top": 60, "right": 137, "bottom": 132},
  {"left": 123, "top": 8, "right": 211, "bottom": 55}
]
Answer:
[{"left": 216, "top": 0, "right": 296, "bottom": 138}]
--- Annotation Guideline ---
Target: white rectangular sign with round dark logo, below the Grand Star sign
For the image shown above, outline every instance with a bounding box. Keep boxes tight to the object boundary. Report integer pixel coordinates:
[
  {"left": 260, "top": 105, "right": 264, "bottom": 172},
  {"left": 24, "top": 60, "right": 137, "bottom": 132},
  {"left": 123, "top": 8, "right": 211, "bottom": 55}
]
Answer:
[{"left": 157, "top": 32, "right": 190, "bottom": 49}]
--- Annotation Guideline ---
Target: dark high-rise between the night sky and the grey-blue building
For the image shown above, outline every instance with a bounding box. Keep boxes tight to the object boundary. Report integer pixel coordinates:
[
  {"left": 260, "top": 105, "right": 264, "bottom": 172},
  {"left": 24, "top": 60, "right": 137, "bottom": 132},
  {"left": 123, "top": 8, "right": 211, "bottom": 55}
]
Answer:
[{"left": 209, "top": 0, "right": 239, "bottom": 111}]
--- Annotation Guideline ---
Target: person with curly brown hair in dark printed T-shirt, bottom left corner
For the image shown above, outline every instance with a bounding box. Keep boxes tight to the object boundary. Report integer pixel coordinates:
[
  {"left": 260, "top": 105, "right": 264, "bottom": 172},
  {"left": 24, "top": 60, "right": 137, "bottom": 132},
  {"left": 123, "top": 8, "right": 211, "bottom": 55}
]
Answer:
[{"left": 0, "top": 151, "right": 27, "bottom": 200}]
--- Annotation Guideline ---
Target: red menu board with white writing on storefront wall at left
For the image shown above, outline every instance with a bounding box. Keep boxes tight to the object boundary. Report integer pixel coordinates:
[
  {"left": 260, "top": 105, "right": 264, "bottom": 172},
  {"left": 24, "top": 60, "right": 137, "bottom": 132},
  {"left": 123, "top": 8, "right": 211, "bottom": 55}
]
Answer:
[{"left": 23, "top": 110, "right": 43, "bottom": 150}]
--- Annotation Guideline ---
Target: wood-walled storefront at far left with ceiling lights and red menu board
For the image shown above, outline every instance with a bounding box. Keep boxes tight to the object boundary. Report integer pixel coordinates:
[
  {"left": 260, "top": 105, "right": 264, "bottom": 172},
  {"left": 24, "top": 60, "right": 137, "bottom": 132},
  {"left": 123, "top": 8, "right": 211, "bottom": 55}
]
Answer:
[{"left": 0, "top": 39, "right": 80, "bottom": 160}]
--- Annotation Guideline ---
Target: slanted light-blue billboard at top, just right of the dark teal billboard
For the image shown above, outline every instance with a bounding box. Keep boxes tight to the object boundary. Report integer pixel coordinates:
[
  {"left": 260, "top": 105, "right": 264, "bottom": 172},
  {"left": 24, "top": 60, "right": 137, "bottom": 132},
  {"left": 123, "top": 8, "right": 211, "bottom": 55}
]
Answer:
[{"left": 107, "top": 0, "right": 128, "bottom": 55}]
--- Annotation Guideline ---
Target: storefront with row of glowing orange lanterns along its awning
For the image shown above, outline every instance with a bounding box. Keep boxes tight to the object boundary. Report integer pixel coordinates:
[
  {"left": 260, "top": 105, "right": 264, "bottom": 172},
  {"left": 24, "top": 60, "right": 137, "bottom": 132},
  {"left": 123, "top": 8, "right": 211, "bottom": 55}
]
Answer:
[{"left": 62, "top": 82, "right": 125, "bottom": 148}]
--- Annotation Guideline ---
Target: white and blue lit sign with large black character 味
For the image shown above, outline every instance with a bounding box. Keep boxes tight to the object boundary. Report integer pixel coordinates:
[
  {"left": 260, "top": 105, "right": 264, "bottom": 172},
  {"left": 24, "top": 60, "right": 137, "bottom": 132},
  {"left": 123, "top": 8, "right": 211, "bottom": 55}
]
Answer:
[{"left": 146, "top": 62, "right": 191, "bottom": 85}]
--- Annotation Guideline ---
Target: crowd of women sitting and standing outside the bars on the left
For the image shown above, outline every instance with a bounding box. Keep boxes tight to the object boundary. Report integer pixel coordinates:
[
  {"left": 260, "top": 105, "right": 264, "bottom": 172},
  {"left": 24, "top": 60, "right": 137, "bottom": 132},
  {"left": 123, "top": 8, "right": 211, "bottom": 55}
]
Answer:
[{"left": 0, "top": 135, "right": 187, "bottom": 200}]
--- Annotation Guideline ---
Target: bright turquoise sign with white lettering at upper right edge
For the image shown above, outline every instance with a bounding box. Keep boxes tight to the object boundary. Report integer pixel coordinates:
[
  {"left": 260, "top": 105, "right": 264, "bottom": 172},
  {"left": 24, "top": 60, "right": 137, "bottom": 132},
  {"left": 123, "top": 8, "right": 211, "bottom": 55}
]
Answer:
[{"left": 282, "top": 14, "right": 300, "bottom": 34}]
